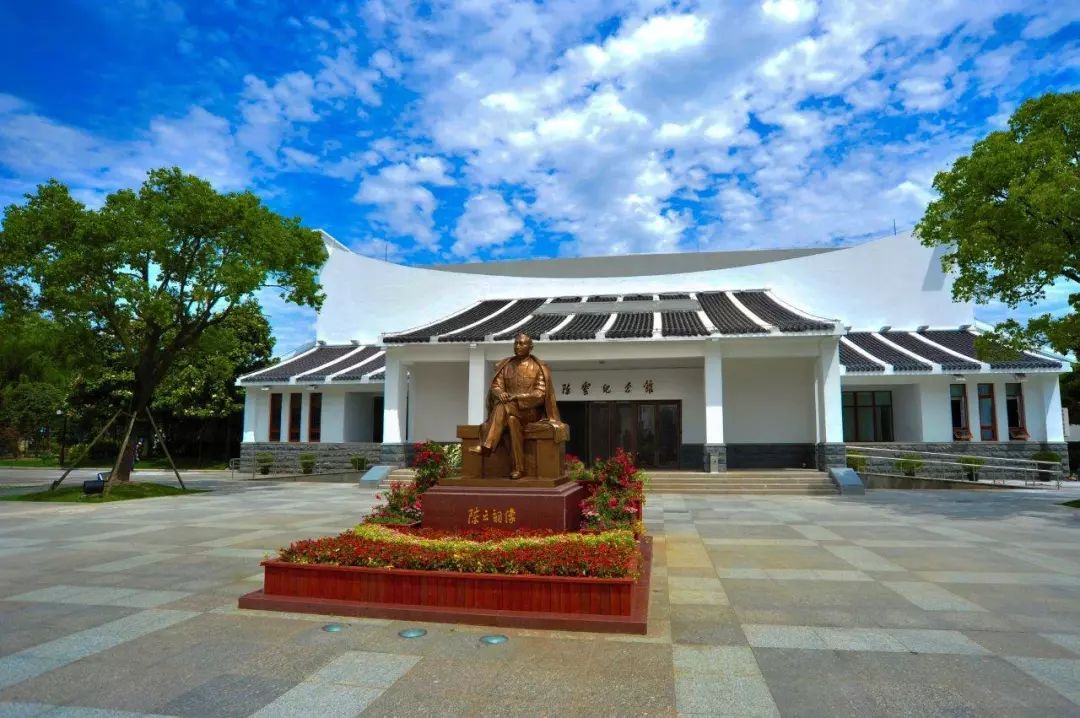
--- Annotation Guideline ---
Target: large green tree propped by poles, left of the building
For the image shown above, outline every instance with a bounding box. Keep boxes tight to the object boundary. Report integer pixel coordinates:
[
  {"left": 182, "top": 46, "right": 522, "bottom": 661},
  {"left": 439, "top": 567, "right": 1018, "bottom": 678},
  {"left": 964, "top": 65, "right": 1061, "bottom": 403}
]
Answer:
[{"left": 0, "top": 167, "right": 326, "bottom": 480}]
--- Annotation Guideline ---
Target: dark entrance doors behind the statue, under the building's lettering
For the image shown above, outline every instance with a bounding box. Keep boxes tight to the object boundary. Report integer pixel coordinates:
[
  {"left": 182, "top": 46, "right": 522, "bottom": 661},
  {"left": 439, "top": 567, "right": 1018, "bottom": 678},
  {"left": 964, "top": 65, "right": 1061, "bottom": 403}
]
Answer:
[{"left": 559, "top": 402, "right": 681, "bottom": 469}]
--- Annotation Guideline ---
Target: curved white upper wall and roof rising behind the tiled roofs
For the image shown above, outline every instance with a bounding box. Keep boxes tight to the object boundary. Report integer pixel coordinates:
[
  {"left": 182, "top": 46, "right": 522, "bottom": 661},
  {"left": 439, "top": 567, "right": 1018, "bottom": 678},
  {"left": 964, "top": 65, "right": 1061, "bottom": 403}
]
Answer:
[{"left": 316, "top": 229, "right": 974, "bottom": 343}]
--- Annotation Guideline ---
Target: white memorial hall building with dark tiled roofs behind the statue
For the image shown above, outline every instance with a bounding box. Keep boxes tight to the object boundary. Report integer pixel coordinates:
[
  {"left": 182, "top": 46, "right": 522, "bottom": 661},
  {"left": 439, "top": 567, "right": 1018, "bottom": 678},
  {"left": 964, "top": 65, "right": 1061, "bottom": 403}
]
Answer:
[{"left": 240, "top": 235, "right": 1068, "bottom": 471}]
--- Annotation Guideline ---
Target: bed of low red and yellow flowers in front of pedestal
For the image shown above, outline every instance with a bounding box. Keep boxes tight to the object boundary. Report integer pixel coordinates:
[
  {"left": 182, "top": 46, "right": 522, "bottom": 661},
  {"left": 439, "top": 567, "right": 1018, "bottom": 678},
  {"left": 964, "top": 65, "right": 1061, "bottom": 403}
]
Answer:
[{"left": 279, "top": 524, "right": 640, "bottom": 579}]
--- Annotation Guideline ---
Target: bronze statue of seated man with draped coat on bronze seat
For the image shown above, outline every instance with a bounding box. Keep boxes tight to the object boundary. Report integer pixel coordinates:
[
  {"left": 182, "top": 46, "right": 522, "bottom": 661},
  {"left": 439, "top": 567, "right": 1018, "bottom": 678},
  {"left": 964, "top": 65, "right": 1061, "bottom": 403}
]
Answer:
[{"left": 458, "top": 334, "right": 570, "bottom": 482}]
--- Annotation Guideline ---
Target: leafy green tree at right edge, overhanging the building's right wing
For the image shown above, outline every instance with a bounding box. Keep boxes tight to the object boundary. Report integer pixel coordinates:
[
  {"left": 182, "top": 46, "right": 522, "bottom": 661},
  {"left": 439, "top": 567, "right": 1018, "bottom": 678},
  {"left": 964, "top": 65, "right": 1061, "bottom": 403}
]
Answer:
[{"left": 916, "top": 93, "right": 1080, "bottom": 355}]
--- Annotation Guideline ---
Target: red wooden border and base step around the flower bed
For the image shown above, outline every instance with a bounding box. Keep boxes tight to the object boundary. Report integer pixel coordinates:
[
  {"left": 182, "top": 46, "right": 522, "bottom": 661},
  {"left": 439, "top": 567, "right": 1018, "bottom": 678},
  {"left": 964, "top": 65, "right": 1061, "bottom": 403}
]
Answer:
[{"left": 240, "top": 537, "right": 652, "bottom": 634}]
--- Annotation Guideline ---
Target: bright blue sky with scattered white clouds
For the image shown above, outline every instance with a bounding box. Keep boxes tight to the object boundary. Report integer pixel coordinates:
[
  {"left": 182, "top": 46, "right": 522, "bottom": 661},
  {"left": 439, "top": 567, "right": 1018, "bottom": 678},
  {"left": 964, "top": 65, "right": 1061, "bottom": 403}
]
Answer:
[{"left": 0, "top": 0, "right": 1080, "bottom": 351}]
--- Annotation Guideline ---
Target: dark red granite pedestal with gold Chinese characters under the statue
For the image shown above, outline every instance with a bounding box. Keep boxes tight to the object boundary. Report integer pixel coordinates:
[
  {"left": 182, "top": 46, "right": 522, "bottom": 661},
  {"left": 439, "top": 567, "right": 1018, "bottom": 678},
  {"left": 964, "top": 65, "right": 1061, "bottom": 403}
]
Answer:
[{"left": 423, "top": 479, "right": 585, "bottom": 531}]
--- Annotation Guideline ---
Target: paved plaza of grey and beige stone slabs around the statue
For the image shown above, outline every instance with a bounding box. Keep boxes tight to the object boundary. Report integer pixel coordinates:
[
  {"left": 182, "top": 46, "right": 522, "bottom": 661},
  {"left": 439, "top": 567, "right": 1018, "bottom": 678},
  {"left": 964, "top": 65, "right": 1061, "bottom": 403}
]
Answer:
[{"left": 0, "top": 480, "right": 1080, "bottom": 718}]
